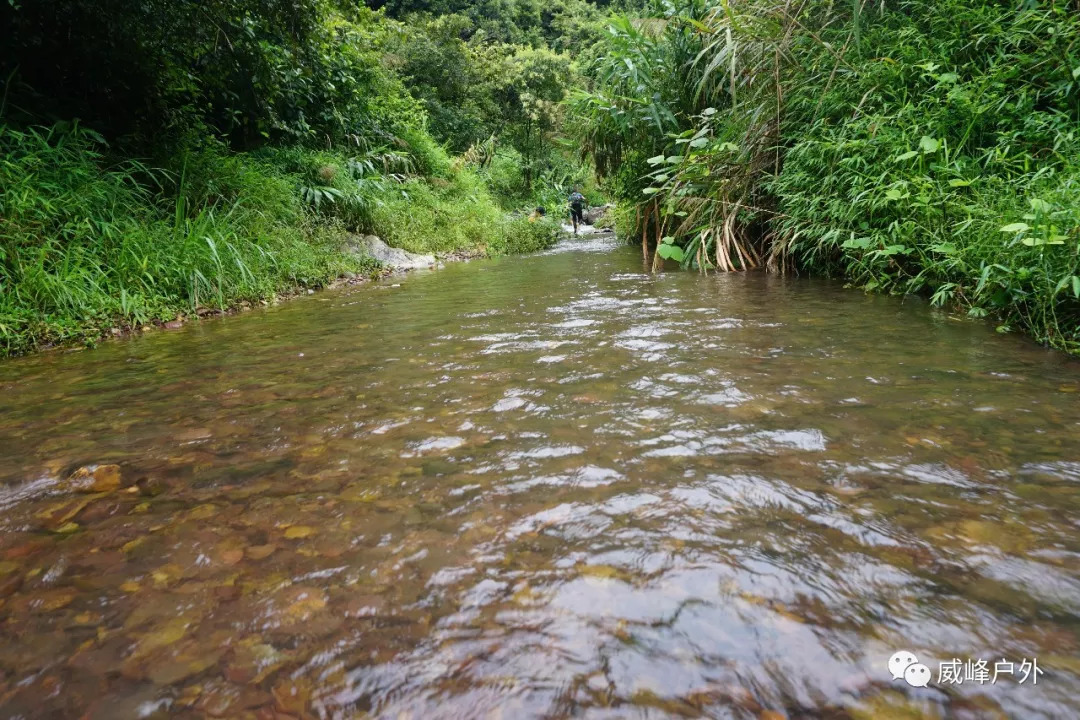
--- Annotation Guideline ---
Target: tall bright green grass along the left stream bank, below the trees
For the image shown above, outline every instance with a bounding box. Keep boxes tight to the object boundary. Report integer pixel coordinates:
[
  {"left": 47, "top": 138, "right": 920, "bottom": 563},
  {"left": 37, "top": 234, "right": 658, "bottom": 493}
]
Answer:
[{"left": 0, "top": 123, "right": 555, "bottom": 355}]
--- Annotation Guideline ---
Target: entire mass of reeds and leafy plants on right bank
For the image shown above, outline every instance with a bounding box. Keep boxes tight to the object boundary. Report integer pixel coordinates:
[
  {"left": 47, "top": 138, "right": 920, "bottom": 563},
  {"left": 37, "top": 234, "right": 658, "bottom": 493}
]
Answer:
[{"left": 576, "top": 0, "right": 1080, "bottom": 352}]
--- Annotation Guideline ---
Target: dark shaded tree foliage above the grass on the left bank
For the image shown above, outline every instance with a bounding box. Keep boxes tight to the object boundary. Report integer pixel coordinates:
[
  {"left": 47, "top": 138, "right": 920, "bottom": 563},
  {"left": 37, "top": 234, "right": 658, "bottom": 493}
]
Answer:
[{"left": 0, "top": 0, "right": 422, "bottom": 149}]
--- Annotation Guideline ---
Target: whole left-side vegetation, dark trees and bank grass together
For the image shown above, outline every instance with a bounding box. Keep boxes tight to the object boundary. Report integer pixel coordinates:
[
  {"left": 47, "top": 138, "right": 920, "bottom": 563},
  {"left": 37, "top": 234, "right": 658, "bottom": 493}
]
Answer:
[{"left": 0, "top": 0, "right": 599, "bottom": 353}]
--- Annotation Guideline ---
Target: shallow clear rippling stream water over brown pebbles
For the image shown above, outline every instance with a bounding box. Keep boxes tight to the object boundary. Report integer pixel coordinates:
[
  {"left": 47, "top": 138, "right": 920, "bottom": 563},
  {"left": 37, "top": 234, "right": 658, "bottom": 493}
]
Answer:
[{"left": 0, "top": 240, "right": 1080, "bottom": 720}]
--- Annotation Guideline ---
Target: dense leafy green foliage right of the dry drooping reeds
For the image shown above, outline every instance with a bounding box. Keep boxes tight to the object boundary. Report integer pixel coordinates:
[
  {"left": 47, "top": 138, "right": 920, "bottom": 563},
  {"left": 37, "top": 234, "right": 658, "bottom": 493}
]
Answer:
[{"left": 769, "top": 0, "right": 1080, "bottom": 350}]
